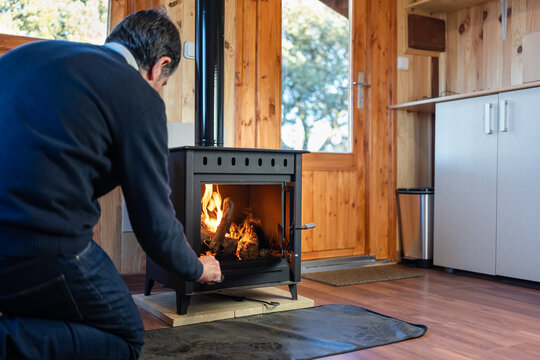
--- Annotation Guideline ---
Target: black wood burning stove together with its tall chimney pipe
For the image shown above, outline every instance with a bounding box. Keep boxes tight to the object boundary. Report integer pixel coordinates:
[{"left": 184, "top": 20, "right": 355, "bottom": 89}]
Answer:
[{"left": 145, "top": 0, "right": 314, "bottom": 314}]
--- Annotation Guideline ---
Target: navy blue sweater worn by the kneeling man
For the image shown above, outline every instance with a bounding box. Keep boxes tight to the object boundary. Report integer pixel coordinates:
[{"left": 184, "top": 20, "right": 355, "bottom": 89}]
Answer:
[{"left": 0, "top": 41, "right": 203, "bottom": 279}]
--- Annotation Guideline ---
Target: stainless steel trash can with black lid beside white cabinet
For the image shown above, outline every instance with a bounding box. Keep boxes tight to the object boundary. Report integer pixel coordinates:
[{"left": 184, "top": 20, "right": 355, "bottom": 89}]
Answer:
[{"left": 397, "top": 188, "right": 434, "bottom": 267}]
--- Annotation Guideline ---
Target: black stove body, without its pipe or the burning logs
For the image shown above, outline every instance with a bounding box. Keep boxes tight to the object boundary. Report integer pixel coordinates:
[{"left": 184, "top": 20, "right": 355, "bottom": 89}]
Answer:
[{"left": 145, "top": 147, "right": 309, "bottom": 314}]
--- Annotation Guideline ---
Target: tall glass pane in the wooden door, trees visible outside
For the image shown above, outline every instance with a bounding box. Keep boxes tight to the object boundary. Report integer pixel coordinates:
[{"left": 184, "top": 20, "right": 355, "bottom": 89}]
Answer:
[{"left": 281, "top": 0, "right": 351, "bottom": 153}]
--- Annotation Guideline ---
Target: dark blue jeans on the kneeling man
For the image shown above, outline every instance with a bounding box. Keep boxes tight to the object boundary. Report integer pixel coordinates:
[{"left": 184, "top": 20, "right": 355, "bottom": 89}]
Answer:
[{"left": 0, "top": 241, "right": 143, "bottom": 359}]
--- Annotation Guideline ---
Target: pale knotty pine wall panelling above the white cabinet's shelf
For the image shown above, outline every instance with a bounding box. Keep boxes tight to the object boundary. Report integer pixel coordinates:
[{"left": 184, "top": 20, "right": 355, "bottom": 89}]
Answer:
[{"left": 442, "top": 0, "right": 540, "bottom": 93}]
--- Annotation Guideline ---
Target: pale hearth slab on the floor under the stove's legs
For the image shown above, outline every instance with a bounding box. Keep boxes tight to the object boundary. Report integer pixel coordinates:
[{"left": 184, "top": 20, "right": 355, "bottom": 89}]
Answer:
[{"left": 133, "top": 287, "right": 315, "bottom": 326}]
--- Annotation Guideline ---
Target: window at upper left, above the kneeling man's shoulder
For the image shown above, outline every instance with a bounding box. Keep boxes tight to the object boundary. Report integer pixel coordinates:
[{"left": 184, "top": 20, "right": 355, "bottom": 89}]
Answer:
[{"left": 0, "top": 0, "right": 109, "bottom": 44}]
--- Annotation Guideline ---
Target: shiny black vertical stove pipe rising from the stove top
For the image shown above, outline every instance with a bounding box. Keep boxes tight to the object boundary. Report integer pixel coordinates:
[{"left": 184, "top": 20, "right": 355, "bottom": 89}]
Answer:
[{"left": 195, "top": 0, "right": 225, "bottom": 146}]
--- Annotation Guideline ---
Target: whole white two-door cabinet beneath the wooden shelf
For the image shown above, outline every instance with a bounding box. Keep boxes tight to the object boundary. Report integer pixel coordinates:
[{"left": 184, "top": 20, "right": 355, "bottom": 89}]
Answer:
[{"left": 433, "top": 88, "right": 540, "bottom": 281}]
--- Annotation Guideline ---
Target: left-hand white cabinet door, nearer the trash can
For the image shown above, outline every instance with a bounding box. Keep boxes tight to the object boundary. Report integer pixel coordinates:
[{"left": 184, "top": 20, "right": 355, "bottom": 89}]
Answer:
[{"left": 433, "top": 95, "right": 498, "bottom": 274}]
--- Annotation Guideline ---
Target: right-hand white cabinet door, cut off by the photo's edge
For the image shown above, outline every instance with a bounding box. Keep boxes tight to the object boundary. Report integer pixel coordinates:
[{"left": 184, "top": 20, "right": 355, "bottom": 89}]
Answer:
[{"left": 496, "top": 88, "right": 540, "bottom": 281}]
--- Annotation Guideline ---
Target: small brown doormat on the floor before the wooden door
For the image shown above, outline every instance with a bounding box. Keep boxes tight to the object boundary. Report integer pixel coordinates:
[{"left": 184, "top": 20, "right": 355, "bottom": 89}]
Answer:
[{"left": 302, "top": 264, "right": 423, "bottom": 286}]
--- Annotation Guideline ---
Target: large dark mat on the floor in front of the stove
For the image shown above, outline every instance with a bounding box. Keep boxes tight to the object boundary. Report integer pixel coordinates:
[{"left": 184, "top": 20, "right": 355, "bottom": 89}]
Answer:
[{"left": 140, "top": 305, "right": 427, "bottom": 360}]
